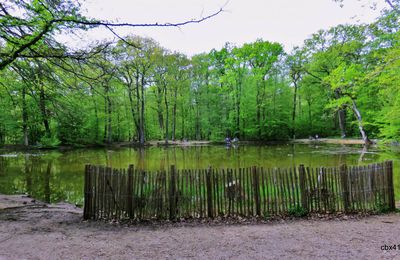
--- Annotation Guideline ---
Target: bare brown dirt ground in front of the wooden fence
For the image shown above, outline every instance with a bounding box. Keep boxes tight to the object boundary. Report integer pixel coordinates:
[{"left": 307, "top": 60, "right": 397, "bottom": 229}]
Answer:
[{"left": 0, "top": 195, "right": 400, "bottom": 259}]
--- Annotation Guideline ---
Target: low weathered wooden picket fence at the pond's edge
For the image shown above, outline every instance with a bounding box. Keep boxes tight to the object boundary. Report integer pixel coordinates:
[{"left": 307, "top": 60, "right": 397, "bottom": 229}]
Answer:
[{"left": 84, "top": 161, "right": 395, "bottom": 220}]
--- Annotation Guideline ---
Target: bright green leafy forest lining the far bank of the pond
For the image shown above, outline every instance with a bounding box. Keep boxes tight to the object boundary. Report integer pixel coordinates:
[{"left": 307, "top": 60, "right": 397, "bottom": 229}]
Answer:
[{"left": 0, "top": 1, "right": 400, "bottom": 147}]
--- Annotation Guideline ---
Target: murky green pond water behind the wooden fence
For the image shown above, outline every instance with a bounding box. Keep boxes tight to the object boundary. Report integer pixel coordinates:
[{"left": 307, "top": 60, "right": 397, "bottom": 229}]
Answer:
[{"left": 0, "top": 144, "right": 400, "bottom": 205}]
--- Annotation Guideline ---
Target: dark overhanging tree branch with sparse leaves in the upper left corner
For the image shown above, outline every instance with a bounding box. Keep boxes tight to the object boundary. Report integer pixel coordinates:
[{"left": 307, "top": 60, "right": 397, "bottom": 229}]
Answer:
[{"left": 0, "top": 0, "right": 223, "bottom": 71}]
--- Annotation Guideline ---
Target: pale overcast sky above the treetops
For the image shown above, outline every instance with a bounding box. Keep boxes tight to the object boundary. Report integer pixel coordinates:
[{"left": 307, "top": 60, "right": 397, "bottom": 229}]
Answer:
[{"left": 67, "top": 0, "right": 384, "bottom": 55}]
